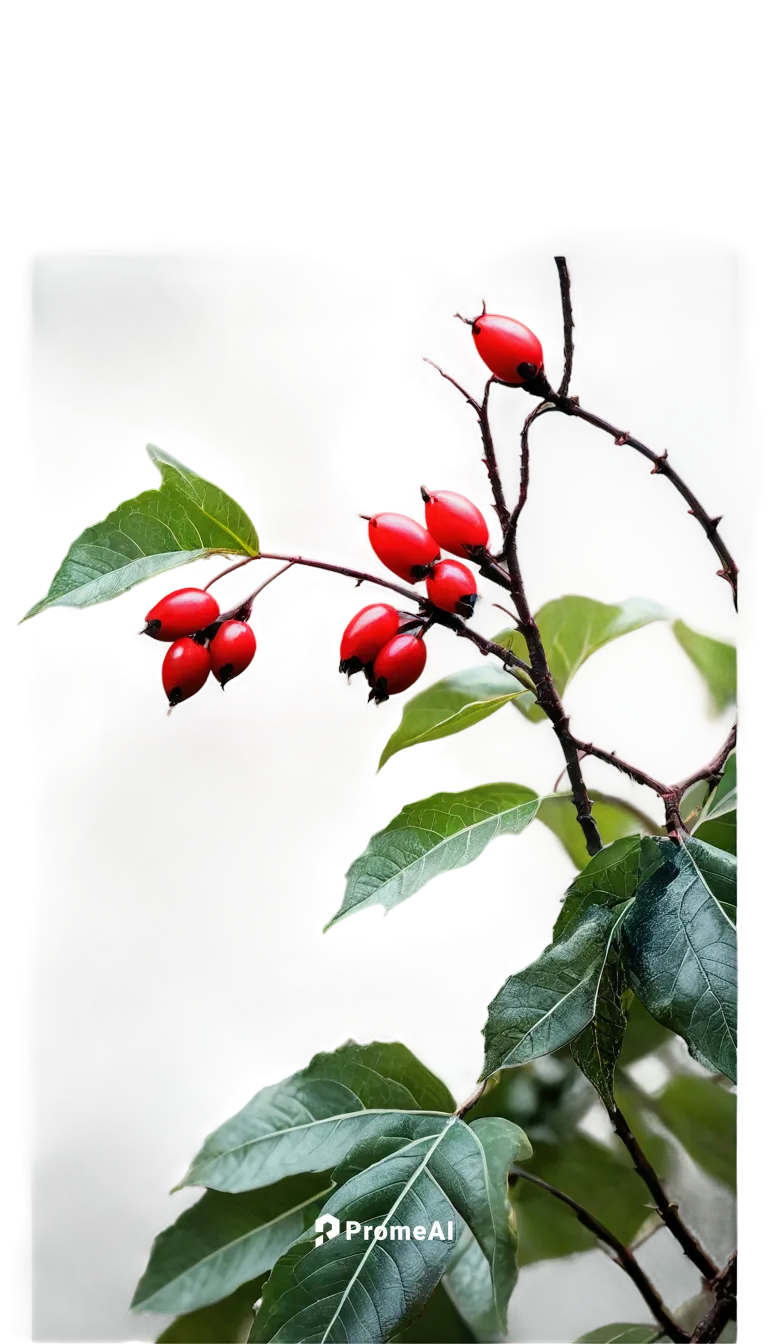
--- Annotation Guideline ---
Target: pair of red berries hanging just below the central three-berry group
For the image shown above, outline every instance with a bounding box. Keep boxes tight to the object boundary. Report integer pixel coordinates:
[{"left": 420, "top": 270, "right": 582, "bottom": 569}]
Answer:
[{"left": 339, "top": 602, "right": 426, "bottom": 703}]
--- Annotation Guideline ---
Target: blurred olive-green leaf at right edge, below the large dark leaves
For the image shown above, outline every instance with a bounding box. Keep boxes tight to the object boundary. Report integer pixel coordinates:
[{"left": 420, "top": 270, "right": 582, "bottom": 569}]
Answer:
[{"left": 658, "top": 1078, "right": 736, "bottom": 1188}]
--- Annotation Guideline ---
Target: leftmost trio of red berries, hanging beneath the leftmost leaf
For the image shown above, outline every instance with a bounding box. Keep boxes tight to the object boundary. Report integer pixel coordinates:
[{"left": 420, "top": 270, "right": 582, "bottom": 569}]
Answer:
[{"left": 144, "top": 587, "right": 256, "bottom": 704}]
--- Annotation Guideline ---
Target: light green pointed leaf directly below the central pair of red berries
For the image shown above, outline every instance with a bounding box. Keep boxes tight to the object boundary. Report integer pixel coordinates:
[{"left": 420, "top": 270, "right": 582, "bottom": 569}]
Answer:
[{"left": 381, "top": 671, "right": 522, "bottom": 763}]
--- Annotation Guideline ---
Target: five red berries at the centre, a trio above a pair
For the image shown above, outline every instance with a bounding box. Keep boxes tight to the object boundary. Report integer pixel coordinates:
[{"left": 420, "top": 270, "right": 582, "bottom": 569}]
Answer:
[{"left": 339, "top": 488, "right": 490, "bottom": 703}]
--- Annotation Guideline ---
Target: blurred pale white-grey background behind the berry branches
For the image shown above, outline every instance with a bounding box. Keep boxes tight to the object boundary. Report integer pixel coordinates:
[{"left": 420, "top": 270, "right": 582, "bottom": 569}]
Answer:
[{"left": 19, "top": 230, "right": 749, "bottom": 1344}]
